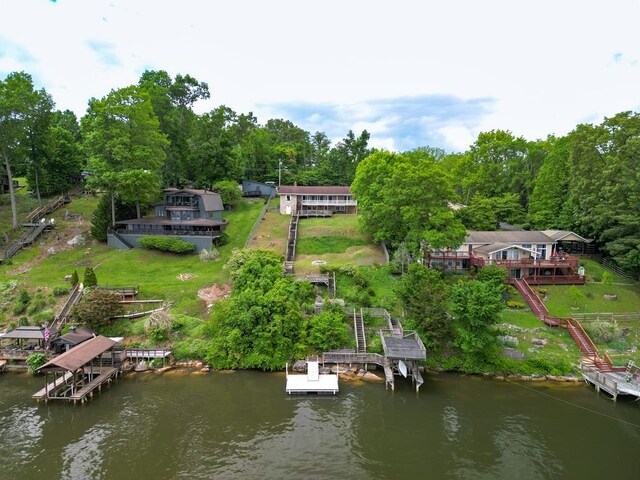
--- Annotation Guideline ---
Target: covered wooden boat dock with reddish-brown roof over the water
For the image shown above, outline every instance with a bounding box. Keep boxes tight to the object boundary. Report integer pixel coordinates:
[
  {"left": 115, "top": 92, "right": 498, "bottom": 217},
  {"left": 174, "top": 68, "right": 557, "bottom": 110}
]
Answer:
[{"left": 33, "top": 336, "right": 121, "bottom": 403}]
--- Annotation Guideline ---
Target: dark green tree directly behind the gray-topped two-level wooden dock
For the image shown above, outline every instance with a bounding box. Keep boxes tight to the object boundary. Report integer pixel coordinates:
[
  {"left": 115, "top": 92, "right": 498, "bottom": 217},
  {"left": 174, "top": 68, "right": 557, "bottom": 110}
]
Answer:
[{"left": 398, "top": 263, "right": 451, "bottom": 349}]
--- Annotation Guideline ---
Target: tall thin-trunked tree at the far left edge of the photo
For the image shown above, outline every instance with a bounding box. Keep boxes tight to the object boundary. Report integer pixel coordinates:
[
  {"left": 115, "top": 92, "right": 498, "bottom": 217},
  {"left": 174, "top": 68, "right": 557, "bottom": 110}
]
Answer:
[{"left": 0, "top": 72, "right": 38, "bottom": 230}]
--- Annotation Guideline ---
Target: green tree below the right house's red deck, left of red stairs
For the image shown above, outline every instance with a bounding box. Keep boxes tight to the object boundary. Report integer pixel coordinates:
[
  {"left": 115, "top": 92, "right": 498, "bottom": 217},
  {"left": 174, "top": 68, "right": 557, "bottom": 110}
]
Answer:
[{"left": 451, "top": 280, "right": 503, "bottom": 356}]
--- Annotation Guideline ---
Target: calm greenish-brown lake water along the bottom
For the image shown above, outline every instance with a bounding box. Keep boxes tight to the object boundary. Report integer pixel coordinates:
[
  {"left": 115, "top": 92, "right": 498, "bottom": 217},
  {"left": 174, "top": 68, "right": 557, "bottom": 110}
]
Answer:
[{"left": 0, "top": 372, "right": 640, "bottom": 480}]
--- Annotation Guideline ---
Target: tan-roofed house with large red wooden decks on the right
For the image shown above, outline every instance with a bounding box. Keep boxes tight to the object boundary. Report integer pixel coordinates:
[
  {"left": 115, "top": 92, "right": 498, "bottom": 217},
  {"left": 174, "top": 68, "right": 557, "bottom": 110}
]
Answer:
[{"left": 424, "top": 230, "right": 591, "bottom": 285}]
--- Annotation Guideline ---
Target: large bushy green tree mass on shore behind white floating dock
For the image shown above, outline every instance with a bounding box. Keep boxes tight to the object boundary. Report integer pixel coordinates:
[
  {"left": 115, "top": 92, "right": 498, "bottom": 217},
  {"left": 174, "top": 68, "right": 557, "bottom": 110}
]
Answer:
[{"left": 206, "top": 250, "right": 313, "bottom": 370}]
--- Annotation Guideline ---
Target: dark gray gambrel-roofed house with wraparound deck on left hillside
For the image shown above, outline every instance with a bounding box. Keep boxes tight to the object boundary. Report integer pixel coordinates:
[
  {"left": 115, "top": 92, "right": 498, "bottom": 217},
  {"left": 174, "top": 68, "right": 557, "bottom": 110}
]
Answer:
[{"left": 107, "top": 188, "right": 227, "bottom": 252}]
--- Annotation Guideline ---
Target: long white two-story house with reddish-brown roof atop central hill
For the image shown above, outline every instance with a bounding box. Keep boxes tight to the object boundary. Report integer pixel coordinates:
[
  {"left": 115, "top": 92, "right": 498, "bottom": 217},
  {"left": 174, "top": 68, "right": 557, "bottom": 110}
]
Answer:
[{"left": 278, "top": 185, "right": 358, "bottom": 217}]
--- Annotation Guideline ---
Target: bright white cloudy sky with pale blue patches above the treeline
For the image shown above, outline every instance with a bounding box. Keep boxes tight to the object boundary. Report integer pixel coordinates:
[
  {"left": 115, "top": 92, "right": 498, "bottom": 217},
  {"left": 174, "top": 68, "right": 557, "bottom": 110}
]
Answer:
[{"left": 0, "top": 0, "right": 640, "bottom": 151}]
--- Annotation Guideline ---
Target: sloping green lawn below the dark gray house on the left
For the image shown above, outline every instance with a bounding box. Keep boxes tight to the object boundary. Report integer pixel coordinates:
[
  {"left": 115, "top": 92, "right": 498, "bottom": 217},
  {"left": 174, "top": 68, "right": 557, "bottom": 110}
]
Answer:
[{"left": 0, "top": 198, "right": 264, "bottom": 323}]
